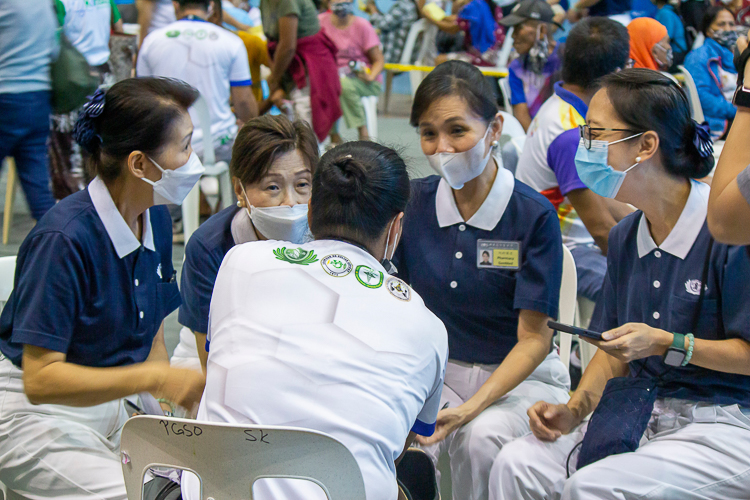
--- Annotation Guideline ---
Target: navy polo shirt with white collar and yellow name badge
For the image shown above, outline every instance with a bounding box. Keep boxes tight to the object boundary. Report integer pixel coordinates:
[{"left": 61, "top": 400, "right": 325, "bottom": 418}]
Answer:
[{"left": 394, "top": 167, "right": 562, "bottom": 364}]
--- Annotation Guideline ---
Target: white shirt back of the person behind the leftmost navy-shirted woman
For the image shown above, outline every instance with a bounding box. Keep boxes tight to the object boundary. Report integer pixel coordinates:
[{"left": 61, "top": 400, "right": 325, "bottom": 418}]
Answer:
[{"left": 137, "top": 20, "right": 250, "bottom": 154}]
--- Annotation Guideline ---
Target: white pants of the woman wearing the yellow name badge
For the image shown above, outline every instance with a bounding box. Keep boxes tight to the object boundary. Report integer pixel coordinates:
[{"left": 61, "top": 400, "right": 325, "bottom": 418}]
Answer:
[{"left": 424, "top": 352, "right": 570, "bottom": 500}]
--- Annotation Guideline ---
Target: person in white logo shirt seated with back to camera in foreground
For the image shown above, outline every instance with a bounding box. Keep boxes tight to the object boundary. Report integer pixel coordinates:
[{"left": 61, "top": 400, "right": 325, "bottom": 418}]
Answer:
[{"left": 182, "top": 141, "right": 448, "bottom": 500}]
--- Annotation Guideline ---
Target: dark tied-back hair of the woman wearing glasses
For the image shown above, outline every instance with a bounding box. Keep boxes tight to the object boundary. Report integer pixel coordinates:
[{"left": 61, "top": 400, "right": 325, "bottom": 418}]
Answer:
[{"left": 602, "top": 68, "right": 714, "bottom": 179}]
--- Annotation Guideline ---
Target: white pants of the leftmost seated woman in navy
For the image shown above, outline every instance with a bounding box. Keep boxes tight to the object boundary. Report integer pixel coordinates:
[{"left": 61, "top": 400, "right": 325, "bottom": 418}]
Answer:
[{"left": 0, "top": 354, "right": 127, "bottom": 500}]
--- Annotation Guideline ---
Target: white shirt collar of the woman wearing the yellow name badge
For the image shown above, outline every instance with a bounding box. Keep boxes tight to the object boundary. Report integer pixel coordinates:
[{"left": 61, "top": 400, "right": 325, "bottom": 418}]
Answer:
[{"left": 435, "top": 158, "right": 516, "bottom": 231}]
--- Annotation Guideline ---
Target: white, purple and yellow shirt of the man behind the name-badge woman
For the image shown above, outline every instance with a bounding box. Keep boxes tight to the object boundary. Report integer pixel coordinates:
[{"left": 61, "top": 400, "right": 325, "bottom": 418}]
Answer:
[{"left": 516, "top": 82, "right": 594, "bottom": 248}]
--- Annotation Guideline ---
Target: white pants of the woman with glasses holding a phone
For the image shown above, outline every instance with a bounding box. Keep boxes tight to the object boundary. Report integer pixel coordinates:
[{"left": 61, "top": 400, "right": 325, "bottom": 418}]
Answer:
[{"left": 490, "top": 399, "right": 750, "bottom": 500}]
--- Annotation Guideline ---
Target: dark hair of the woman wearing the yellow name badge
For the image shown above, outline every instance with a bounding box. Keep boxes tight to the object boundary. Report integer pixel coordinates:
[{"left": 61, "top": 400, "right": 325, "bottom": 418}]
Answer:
[{"left": 409, "top": 61, "right": 498, "bottom": 127}]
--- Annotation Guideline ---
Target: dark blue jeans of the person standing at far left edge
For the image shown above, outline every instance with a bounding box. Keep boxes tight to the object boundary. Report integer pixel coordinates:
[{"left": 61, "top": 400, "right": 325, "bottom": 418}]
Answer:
[{"left": 0, "top": 91, "right": 55, "bottom": 220}]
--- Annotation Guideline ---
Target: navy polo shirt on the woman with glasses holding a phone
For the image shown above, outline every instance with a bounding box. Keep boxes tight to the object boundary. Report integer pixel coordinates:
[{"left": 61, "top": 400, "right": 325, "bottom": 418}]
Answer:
[{"left": 592, "top": 181, "right": 750, "bottom": 407}]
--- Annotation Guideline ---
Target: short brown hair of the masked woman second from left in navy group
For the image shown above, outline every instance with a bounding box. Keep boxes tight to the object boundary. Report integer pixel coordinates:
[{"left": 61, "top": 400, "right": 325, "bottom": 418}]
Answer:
[{"left": 229, "top": 115, "right": 319, "bottom": 185}]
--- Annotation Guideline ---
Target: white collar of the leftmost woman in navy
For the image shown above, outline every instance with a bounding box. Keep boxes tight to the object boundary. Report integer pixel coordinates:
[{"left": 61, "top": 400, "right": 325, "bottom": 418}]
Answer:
[{"left": 88, "top": 176, "right": 155, "bottom": 259}]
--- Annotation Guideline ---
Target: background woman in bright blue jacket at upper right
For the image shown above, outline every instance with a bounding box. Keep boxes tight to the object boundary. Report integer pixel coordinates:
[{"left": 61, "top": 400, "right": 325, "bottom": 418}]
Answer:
[{"left": 685, "top": 5, "right": 737, "bottom": 138}]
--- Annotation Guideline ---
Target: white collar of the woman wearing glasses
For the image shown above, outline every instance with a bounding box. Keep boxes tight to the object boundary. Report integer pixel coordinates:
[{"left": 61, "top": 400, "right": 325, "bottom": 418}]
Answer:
[{"left": 636, "top": 181, "right": 711, "bottom": 260}]
